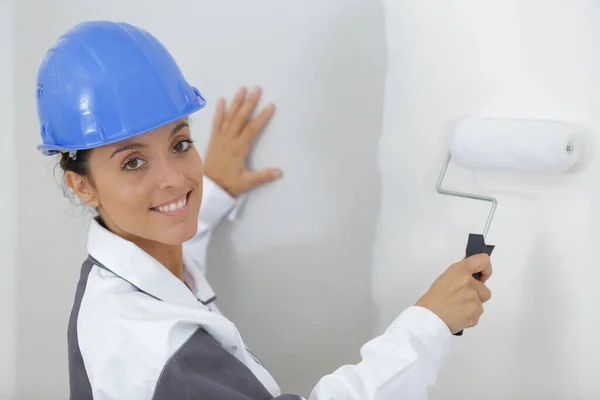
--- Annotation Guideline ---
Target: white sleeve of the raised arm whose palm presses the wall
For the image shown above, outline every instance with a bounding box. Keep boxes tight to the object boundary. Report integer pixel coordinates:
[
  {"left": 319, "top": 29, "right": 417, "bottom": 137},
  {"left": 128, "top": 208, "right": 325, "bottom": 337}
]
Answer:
[{"left": 183, "top": 175, "right": 245, "bottom": 274}]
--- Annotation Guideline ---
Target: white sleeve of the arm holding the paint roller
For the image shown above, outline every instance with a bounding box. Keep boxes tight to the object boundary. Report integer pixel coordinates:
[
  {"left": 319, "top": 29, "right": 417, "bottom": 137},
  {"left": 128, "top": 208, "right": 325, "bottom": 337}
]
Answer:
[{"left": 309, "top": 306, "right": 452, "bottom": 400}]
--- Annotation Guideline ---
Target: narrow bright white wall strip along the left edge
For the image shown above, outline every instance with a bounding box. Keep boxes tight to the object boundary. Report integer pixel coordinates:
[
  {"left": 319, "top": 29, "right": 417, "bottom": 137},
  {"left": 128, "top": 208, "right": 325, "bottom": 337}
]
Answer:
[{"left": 0, "top": 0, "right": 17, "bottom": 399}]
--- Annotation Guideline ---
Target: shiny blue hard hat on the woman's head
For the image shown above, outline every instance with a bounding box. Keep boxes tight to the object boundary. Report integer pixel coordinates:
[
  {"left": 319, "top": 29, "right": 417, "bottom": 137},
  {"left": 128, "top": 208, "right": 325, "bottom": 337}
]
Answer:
[{"left": 37, "top": 21, "right": 206, "bottom": 155}]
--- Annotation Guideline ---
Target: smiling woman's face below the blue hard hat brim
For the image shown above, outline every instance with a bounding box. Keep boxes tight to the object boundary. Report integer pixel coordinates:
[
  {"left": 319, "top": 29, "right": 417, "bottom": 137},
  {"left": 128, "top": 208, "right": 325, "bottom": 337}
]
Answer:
[{"left": 77, "top": 120, "right": 203, "bottom": 244}]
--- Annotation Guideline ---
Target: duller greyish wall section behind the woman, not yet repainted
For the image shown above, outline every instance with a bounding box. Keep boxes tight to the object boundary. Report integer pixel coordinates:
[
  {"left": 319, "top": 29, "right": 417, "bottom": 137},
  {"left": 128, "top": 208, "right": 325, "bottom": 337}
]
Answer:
[{"left": 14, "top": 0, "right": 386, "bottom": 399}]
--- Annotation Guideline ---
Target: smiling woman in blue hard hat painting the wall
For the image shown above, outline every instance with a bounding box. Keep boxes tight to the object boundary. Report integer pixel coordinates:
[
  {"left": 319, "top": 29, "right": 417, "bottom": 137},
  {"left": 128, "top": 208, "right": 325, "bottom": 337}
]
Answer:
[{"left": 37, "top": 22, "right": 491, "bottom": 400}]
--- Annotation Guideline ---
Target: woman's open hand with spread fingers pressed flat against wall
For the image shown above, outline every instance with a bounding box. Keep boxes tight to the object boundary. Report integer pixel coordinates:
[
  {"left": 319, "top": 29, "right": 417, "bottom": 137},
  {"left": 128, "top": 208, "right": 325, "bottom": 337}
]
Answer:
[{"left": 204, "top": 87, "right": 281, "bottom": 197}]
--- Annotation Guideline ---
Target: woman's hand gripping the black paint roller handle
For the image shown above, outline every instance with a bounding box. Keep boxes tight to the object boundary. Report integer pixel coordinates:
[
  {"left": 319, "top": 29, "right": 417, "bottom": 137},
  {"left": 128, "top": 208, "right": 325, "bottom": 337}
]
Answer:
[{"left": 416, "top": 254, "right": 492, "bottom": 333}]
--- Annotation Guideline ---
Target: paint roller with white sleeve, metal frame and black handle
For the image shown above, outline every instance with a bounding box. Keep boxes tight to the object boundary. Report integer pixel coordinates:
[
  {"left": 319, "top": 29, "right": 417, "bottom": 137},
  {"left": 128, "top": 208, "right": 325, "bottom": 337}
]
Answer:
[{"left": 436, "top": 117, "right": 581, "bottom": 336}]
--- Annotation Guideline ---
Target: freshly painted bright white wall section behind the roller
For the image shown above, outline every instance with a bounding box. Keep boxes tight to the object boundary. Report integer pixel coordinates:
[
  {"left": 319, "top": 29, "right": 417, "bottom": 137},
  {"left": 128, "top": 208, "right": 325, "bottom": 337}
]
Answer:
[{"left": 373, "top": 0, "right": 600, "bottom": 400}]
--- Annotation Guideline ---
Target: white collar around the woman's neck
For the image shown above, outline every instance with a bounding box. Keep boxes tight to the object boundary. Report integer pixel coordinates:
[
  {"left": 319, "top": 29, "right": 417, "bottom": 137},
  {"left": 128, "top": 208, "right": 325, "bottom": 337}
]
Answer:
[{"left": 87, "top": 219, "right": 214, "bottom": 307}]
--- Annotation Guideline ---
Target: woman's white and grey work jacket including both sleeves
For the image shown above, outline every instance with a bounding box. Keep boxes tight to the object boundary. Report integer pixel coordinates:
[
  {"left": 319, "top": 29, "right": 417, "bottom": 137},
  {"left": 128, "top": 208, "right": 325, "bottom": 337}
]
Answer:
[{"left": 68, "top": 177, "right": 452, "bottom": 400}]
